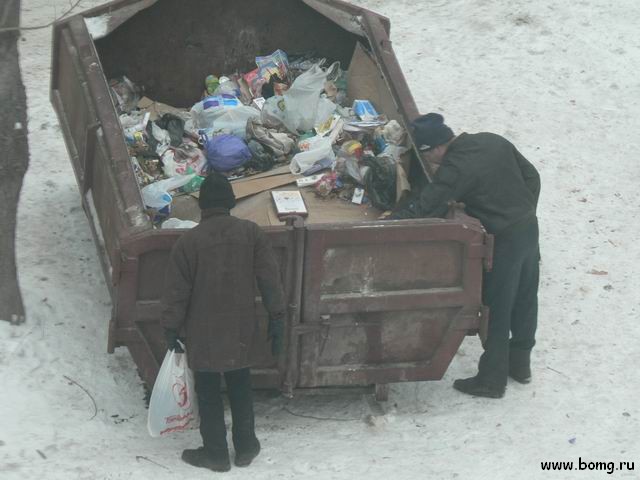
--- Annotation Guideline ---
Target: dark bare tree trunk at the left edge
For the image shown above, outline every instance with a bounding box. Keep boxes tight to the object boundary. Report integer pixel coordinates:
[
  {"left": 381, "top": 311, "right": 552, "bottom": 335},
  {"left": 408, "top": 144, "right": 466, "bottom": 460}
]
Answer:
[{"left": 0, "top": 0, "right": 29, "bottom": 323}]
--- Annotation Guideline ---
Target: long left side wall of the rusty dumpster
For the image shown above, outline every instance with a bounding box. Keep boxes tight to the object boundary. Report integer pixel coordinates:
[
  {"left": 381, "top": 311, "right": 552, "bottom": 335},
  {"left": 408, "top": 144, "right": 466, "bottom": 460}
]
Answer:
[{"left": 51, "top": 16, "right": 150, "bottom": 284}]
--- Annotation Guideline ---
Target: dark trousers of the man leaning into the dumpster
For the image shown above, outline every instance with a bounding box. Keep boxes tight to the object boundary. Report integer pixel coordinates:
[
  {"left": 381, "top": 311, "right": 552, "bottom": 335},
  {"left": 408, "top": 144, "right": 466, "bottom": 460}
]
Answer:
[{"left": 478, "top": 218, "right": 540, "bottom": 387}]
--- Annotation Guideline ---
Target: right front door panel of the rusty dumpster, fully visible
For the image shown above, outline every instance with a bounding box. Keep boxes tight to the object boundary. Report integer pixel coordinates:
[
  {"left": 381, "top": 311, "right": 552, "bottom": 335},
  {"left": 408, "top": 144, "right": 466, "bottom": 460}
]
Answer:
[{"left": 299, "top": 219, "right": 485, "bottom": 387}]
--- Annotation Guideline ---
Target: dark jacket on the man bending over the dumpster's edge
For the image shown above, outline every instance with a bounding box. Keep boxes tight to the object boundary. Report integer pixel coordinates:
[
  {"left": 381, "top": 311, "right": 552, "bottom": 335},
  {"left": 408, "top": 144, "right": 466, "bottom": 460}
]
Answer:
[{"left": 391, "top": 133, "right": 540, "bottom": 234}]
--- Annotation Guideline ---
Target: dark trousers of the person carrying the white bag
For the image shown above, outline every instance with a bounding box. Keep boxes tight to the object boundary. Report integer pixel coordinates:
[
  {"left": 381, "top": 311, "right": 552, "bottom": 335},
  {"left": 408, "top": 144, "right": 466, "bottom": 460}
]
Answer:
[{"left": 195, "top": 368, "right": 258, "bottom": 452}]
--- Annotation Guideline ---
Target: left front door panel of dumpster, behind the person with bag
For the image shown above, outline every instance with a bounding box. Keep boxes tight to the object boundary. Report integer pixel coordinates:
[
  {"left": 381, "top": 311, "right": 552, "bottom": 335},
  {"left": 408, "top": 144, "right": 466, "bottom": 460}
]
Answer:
[{"left": 113, "top": 228, "right": 294, "bottom": 388}]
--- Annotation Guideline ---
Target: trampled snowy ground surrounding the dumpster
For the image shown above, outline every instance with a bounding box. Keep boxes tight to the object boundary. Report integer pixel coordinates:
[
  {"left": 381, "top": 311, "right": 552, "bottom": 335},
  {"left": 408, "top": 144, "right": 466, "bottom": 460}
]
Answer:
[{"left": 0, "top": 0, "right": 640, "bottom": 480}]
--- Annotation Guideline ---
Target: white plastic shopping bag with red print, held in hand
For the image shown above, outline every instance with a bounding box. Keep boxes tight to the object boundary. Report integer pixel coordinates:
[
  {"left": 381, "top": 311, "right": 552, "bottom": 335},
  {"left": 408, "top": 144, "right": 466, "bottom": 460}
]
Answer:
[{"left": 147, "top": 344, "right": 200, "bottom": 437}]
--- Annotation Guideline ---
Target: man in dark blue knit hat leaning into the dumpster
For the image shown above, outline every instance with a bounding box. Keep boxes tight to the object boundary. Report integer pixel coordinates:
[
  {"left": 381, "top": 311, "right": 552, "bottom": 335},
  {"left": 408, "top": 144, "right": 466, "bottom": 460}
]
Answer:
[{"left": 390, "top": 113, "right": 540, "bottom": 398}]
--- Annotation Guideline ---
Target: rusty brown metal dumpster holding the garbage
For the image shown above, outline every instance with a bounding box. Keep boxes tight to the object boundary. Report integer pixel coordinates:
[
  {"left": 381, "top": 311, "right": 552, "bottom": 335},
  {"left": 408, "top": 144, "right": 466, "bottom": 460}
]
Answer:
[{"left": 51, "top": 0, "right": 492, "bottom": 393}]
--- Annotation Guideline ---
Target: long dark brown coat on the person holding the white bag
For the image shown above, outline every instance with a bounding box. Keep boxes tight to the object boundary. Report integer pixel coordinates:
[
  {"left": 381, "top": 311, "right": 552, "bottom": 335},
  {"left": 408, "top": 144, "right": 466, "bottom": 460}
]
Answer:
[{"left": 162, "top": 208, "right": 285, "bottom": 372}]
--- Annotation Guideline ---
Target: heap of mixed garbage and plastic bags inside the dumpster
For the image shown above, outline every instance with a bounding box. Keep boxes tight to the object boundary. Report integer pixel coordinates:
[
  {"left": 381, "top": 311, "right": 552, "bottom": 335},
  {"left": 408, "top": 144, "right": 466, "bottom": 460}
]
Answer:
[{"left": 109, "top": 50, "right": 408, "bottom": 228}]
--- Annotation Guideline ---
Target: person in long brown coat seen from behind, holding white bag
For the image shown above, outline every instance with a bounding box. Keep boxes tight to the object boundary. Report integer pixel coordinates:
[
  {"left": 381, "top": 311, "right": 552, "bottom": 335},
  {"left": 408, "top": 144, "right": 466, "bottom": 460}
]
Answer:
[{"left": 162, "top": 173, "right": 285, "bottom": 471}]
